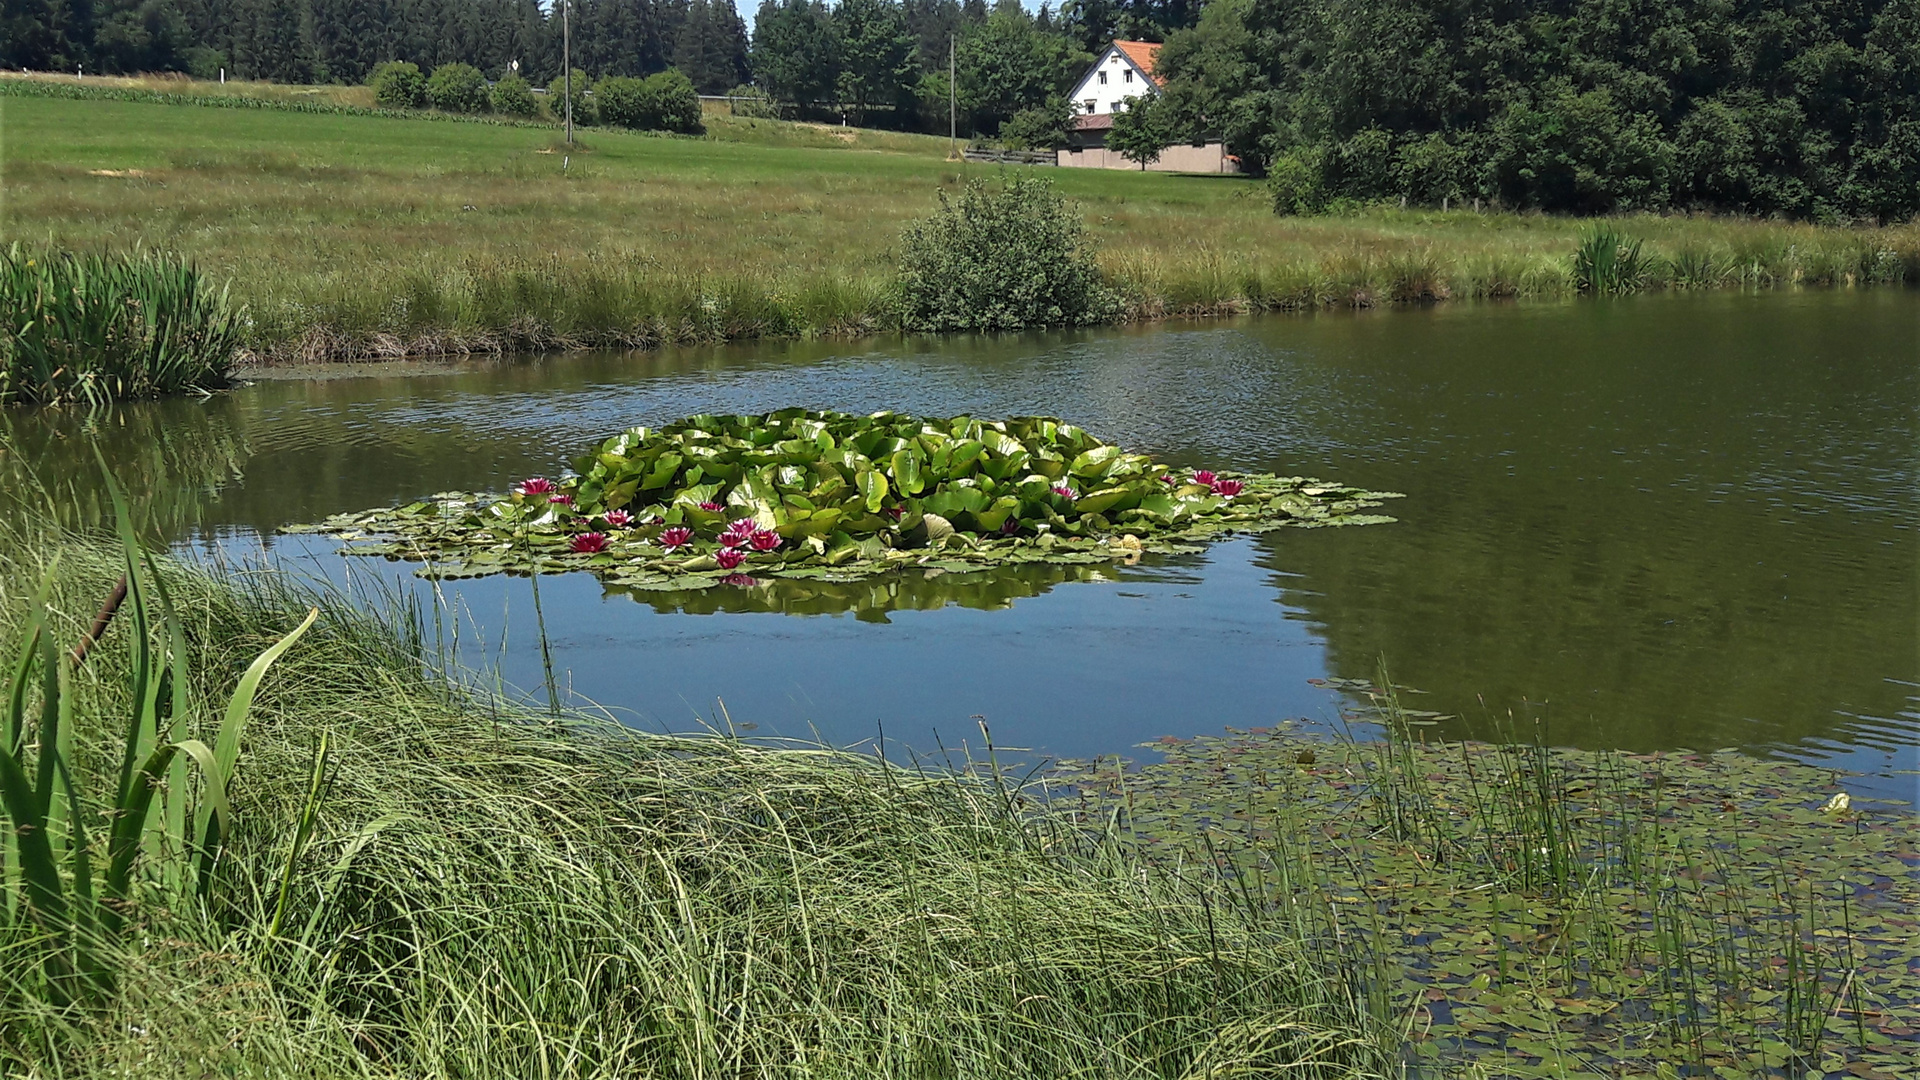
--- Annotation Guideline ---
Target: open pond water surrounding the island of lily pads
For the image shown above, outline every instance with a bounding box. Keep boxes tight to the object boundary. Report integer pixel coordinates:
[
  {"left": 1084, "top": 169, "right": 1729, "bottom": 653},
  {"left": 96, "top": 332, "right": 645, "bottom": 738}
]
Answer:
[{"left": 0, "top": 290, "right": 1920, "bottom": 798}]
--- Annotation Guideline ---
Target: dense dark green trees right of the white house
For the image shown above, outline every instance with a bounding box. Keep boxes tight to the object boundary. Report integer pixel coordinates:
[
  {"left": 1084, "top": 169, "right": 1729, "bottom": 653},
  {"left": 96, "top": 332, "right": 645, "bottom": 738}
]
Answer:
[{"left": 1128, "top": 0, "right": 1920, "bottom": 221}]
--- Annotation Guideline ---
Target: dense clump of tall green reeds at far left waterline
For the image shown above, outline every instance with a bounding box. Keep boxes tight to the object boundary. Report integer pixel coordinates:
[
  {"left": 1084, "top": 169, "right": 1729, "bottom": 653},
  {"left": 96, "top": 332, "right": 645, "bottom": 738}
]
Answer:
[{"left": 0, "top": 244, "right": 242, "bottom": 405}]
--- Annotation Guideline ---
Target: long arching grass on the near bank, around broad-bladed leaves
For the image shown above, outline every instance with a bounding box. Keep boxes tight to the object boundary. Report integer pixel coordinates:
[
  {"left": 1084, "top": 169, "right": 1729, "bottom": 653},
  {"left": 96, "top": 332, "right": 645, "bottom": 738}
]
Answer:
[{"left": 0, "top": 518, "right": 1388, "bottom": 1078}]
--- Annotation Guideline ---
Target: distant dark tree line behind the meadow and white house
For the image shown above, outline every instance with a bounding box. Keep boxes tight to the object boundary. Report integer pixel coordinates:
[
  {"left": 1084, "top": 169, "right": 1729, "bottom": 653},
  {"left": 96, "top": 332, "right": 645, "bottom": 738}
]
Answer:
[{"left": 0, "top": 0, "right": 1202, "bottom": 129}]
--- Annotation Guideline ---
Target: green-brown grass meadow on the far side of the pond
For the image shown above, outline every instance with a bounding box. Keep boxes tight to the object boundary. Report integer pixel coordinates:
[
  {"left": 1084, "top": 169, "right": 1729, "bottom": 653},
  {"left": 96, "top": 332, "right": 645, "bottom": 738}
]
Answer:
[{"left": 0, "top": 81, "right": 1920, "bottom": 357}]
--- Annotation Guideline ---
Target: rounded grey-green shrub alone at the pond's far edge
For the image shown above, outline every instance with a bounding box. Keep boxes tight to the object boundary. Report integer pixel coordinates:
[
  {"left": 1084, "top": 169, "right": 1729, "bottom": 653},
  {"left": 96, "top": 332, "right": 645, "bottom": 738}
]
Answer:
[{"left": 899, "top": 177, "right": 1119, "bottom": 331}]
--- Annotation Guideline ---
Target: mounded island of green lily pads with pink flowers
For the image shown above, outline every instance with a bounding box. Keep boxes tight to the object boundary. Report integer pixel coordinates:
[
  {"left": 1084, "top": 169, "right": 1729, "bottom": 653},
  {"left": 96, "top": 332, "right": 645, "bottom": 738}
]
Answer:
[{"left": 290, "top": 409, "right": 1394, "bottom": 594}]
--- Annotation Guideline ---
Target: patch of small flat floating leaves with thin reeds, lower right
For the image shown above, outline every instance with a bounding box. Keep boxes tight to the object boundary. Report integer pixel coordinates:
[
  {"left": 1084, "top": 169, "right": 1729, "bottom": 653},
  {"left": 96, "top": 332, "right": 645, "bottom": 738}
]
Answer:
[{"left": 1054, "top": 686, "right": 1920, "bottom": 1078}]
